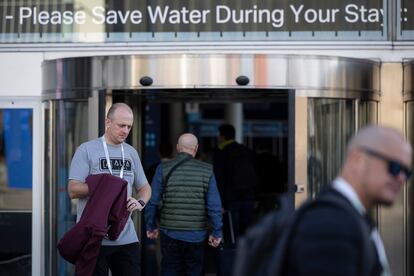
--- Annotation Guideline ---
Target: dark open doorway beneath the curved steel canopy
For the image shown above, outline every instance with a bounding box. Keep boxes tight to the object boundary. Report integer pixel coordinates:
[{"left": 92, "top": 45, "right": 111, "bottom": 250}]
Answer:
[{"left": 110, "top": 89, "right": 294, "bottom": 275}]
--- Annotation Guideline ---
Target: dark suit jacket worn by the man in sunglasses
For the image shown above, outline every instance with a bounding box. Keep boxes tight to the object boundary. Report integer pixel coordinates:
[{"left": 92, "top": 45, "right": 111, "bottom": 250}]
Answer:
[{"left": 283, "top": 187, "right": 382, "bottom": 276}]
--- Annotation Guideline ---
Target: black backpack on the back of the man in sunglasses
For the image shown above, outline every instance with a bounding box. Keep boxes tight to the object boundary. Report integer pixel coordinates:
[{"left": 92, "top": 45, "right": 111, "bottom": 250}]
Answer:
[{"left": 233, "top": 195, "right": 374, "bottom": 276}]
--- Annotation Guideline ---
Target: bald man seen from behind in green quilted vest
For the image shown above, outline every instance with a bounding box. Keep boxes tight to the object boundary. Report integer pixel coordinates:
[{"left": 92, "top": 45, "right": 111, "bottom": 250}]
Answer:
[{"left": 145, "top": 133, "right": 222, "bottom": 275}]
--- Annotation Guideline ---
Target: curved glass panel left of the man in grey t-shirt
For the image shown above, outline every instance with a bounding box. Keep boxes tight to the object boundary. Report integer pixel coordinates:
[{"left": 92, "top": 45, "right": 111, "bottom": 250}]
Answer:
[{"left": 46, "top": 100, "right": 88, "bottom": 275}]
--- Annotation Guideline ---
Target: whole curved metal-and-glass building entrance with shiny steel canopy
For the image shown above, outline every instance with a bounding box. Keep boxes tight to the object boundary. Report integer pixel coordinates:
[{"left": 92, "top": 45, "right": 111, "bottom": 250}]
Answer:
[{"left": 41, "top": 55, "right": 379, "bottom": 275}]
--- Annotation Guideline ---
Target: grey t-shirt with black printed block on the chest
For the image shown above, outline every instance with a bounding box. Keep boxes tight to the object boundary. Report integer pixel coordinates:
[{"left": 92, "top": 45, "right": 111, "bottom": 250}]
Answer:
[{"left": 69, "top": 138, "right": 148, "bottom": 245}]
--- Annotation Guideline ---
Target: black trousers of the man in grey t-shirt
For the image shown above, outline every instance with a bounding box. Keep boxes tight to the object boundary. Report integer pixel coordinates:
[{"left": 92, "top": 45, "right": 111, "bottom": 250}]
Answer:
[{"left": 93, "top": 242, "right": 141, "bottom": 276}]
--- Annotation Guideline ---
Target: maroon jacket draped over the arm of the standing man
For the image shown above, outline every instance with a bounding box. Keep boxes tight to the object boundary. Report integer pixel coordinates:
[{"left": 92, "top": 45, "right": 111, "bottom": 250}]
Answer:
[{"left": 57, "top": 174, "right": 129, "bottom": 276}]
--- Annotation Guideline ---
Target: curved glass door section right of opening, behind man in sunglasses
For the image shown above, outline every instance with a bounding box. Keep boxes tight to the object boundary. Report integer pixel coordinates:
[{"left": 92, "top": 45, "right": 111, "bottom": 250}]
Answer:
[{"left": 295, "top": 97, "right": 378, "bottom": 204}]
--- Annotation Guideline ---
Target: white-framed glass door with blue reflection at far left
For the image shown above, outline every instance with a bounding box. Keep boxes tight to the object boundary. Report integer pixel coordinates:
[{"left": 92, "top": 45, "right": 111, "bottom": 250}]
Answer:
[{"left": 0, "top": 99, "right": 44, "bottom": 276}]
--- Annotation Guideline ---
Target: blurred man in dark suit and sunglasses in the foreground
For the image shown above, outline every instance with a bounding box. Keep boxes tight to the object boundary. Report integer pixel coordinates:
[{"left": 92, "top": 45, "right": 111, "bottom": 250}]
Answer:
[{"left": 283, "top": 126, "right": 412, "bottom": 276}]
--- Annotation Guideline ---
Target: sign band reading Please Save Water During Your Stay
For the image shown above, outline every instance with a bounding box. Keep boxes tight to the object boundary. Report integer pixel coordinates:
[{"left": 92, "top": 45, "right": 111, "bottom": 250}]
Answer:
[{"left": 0, "top": 0, "right": 387, "bottom": 41}]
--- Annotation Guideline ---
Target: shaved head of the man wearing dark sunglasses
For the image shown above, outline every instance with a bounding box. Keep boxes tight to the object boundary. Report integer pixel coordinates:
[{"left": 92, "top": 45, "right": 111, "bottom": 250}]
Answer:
[{"left": 341, "top": 125, "right": 412, "bottom": 209}]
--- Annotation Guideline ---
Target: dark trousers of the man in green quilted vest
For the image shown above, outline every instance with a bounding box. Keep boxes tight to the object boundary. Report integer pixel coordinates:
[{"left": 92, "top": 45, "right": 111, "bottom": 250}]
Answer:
[{"left": 161, "top": 233, "right": 205, "bottom": 276}]
